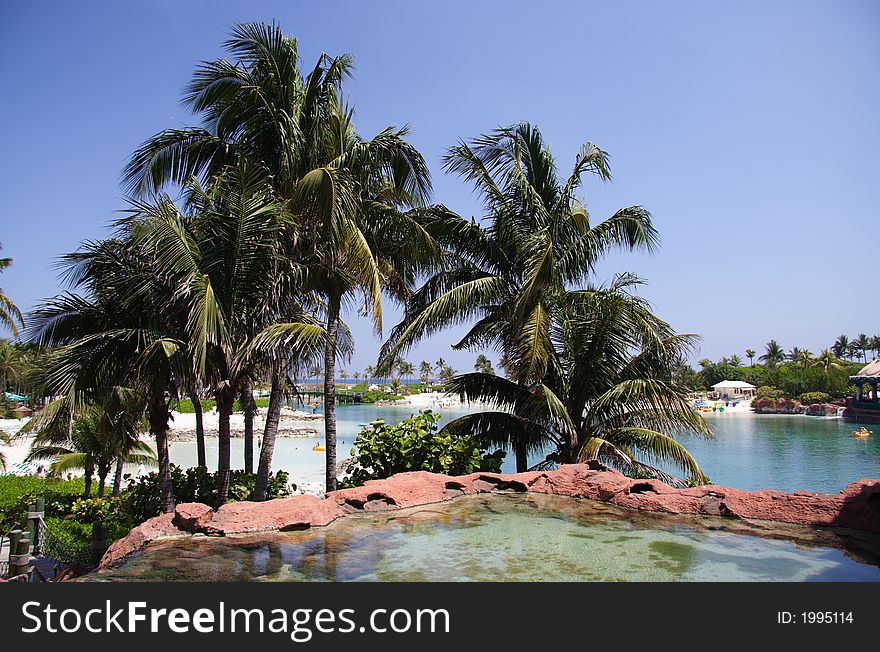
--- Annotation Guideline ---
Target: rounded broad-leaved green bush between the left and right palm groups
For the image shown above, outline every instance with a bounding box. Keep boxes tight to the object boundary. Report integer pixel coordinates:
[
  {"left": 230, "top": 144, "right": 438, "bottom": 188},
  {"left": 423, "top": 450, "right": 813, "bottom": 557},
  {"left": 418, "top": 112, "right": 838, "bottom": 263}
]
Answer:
[{"left": 344, "top": 410, "right": 504, "bottom": 486}]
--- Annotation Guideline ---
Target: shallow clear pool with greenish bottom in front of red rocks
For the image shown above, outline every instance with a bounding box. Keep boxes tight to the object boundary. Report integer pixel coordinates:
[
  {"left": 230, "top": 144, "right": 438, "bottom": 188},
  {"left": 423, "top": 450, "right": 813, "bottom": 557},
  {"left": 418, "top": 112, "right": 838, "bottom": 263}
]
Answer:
[{"left": 83, "top": 494, "right": 880, "bottom": 582}]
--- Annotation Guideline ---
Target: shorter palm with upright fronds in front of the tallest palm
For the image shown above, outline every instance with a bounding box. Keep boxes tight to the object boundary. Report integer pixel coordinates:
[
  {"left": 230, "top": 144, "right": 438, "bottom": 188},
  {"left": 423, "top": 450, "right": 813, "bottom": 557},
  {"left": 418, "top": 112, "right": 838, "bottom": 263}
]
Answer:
[{"left": 127, "top": 160, "right": 336, "bottom": 505}]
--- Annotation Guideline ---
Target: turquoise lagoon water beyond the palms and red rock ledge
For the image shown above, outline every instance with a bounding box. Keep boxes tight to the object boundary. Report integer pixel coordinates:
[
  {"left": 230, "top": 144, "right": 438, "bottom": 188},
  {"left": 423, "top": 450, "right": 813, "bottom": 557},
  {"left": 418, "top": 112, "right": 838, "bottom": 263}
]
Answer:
[{"left": 171, "top": 405, "right": 880, "bottom": 493}]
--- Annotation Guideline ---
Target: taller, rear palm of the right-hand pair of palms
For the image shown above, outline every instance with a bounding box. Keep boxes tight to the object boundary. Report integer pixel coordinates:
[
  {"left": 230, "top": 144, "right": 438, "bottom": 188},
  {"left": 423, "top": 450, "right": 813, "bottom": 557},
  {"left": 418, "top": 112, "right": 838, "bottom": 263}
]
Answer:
[{"left": 382, "top": 123, "right": 657, "bottom": 470}]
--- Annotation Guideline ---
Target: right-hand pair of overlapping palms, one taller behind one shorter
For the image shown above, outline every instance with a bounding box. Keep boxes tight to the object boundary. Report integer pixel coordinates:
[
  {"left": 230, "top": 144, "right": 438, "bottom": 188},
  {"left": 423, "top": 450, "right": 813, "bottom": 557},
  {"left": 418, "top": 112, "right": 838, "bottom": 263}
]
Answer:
[{"left": 380, "top": 123, "right": 709, "bottom": 481}]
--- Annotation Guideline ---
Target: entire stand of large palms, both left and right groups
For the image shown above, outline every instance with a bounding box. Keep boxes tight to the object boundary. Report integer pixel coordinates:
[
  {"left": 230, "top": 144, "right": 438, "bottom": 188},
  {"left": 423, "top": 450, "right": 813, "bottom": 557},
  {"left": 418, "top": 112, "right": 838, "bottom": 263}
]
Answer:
[{"left": 0, "top": 23, "right": 709, "bottom": 500}]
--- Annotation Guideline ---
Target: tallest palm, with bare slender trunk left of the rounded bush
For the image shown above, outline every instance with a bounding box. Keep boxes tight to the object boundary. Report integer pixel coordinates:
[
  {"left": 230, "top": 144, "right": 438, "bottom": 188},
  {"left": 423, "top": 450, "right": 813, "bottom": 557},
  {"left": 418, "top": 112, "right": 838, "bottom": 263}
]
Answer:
[{"left": 124, "top": 23, "right": 432, "bottom": 491}]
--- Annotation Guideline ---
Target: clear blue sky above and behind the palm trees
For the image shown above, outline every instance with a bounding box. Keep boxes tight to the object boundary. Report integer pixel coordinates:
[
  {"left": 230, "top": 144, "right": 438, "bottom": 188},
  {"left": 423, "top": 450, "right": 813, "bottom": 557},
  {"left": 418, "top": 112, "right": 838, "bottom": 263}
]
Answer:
[{"left": 0, "top": 0, "right": 880, "bottom": 371}]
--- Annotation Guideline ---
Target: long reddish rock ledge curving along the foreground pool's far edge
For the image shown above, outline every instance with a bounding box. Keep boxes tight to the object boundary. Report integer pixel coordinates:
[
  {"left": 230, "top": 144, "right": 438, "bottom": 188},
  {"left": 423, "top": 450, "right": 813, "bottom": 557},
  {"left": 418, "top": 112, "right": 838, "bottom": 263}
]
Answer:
[{"left": 100, "top": 462, "right": 880, "bottom": 568}]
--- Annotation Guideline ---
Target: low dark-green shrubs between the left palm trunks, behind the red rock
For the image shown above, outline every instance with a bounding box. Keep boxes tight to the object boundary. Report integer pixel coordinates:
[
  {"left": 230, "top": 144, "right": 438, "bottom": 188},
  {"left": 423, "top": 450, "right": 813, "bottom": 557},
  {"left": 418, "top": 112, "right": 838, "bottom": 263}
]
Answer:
[{"left": 123, "top": 464, "right": 296, "bottom": 523}]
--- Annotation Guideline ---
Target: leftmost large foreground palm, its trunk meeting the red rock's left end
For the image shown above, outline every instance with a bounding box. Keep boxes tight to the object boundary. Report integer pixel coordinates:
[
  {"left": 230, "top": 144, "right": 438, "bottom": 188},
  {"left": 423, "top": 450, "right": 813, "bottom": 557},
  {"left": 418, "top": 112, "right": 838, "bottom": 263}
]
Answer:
[{"left": 27, "top": 237, "right": 192, "bottom": 513}]
